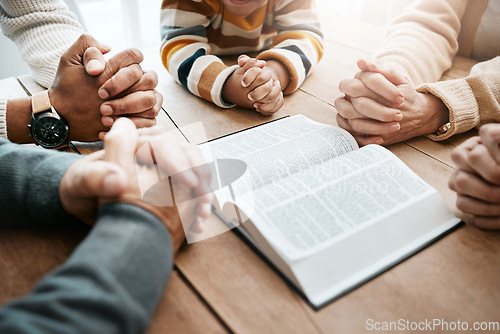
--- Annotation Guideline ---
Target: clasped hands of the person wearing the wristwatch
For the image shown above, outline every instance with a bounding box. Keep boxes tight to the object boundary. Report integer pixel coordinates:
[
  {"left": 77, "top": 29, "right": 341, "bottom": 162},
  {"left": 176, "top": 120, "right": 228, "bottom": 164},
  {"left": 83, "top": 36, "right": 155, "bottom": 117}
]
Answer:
[{"left": 49, "top": 35, "right": 163, "bottom": 141}]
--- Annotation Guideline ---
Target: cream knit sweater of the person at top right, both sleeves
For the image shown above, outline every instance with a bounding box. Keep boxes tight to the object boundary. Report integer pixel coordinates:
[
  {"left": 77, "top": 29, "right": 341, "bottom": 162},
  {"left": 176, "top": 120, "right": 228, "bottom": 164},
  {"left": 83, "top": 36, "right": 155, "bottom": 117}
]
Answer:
[{"left": 377, "top": 0, "right": 500, "bottom": 140}]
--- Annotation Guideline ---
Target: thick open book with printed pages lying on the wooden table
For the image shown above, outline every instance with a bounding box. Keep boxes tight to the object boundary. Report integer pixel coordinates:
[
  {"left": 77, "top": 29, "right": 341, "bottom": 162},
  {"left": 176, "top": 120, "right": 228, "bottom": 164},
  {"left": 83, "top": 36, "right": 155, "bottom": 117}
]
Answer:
[{"left": 200, "top": 116, "right": 460, "bottom": 309}]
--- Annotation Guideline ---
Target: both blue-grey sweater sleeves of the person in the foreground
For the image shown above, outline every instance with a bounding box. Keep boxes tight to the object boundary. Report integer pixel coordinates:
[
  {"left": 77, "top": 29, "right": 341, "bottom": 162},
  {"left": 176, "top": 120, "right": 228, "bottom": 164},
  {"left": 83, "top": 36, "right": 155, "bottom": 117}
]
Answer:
[{"left": 0, "top": 139, "right": 173, "bottom": 334}]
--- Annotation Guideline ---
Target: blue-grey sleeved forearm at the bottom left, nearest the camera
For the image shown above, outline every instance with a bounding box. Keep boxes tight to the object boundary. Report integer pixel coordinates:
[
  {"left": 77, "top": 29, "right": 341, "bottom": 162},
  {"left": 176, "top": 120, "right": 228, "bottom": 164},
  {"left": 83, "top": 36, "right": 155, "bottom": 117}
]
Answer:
[{"left": 0, "top": 203, "right": 173, "bottom": 334}]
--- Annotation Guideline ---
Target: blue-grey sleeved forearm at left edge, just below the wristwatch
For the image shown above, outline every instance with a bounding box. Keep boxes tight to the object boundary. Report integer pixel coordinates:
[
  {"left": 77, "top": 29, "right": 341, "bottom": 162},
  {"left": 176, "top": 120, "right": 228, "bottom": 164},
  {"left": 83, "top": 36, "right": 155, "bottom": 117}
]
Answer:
[{"left": 0, "top": 139, "right": 80, "bottom": 226}]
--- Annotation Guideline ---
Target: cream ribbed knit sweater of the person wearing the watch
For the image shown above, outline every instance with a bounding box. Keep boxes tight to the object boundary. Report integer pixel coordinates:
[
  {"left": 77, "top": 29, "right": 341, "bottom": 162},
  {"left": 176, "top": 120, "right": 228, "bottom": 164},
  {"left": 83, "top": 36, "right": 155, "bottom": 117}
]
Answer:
[{"left": 0, "top": 0, "right": 83, "bottom": 138}]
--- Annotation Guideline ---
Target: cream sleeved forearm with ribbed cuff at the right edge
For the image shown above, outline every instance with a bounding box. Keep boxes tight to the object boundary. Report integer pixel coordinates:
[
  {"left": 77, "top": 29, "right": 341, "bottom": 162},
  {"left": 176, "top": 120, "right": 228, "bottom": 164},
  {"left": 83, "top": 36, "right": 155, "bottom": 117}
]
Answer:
[{"left": 418, "top": 57, "right": 500, "bottom": 140}]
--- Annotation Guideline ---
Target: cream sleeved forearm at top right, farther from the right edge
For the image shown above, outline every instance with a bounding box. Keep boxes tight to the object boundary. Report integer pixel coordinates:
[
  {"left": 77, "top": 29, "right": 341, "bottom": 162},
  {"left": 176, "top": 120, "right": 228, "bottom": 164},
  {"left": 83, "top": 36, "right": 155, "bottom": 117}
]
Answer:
[{"left": 376, "top": 0, "right": 467, "bottom": 86}]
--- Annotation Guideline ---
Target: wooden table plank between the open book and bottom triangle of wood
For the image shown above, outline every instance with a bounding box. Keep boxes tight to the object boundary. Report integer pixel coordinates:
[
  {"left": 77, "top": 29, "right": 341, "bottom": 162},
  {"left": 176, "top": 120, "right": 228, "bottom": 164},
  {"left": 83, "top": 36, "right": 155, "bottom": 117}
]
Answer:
[{"left": 175, "top": 216, "right": 319, "bottom": 333}]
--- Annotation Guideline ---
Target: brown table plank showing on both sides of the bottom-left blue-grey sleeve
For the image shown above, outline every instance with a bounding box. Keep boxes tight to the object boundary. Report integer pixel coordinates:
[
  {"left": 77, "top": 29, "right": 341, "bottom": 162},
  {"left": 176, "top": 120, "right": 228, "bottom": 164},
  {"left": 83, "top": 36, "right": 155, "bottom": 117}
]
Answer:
[{"left": 0, "top": 225, "right": 227, "bottom": 334}]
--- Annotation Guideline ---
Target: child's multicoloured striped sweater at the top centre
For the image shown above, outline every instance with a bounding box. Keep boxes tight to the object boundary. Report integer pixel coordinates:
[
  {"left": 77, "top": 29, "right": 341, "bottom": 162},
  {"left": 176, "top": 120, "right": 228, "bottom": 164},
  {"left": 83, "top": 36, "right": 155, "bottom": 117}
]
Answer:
[{"left": 161, "top": 0, "right": 323, "bottom": 108}]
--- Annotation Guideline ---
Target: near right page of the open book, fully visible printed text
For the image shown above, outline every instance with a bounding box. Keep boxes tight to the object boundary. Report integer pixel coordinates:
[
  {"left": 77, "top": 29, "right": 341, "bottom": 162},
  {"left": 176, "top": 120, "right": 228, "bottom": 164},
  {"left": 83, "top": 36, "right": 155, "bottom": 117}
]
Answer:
[{"left": 238, "top": 145, "right": 436, "bottom": 261}]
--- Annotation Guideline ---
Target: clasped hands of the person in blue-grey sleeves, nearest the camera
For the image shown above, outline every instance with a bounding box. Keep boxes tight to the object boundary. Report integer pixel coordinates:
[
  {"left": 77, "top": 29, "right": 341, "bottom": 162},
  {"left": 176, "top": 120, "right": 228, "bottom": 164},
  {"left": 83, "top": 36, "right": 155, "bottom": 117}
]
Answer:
[{"left": 59, "top": 117, "right": 213, "bottom": 251}]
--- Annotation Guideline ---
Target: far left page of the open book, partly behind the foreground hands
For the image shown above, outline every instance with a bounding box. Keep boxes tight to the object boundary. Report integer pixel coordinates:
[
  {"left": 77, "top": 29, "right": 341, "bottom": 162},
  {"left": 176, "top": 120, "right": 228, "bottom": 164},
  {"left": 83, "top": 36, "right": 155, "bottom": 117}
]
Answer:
[{"left": 200, "top": 115, "right": 358, "bottom": 202}]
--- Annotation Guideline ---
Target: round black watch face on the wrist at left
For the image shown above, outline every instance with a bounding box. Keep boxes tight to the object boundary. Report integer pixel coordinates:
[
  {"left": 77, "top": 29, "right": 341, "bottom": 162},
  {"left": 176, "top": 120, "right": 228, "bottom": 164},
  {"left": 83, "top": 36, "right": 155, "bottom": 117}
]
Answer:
[{"left": 32, "top": 117, "right": 68, "bottom": 148}]
